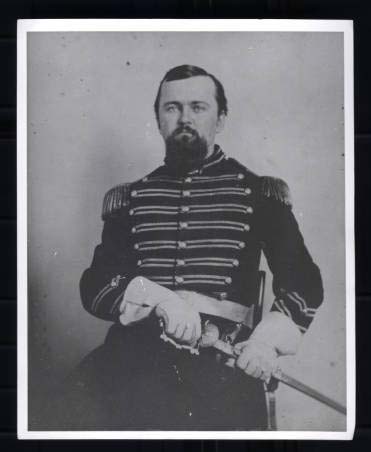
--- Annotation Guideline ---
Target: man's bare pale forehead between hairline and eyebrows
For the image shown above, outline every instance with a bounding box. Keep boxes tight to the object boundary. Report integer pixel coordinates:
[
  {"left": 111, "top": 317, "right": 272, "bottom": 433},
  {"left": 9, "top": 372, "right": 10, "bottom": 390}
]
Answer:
[{"left": 160, "top": 75, "right": 216, "bottom": 104}]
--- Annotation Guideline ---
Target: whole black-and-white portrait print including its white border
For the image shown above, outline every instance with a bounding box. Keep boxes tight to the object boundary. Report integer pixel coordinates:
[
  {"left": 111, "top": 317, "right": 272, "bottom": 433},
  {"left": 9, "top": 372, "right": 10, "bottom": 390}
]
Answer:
[{"left": 18, "top": 20, "right": 355, "bottom": 439}]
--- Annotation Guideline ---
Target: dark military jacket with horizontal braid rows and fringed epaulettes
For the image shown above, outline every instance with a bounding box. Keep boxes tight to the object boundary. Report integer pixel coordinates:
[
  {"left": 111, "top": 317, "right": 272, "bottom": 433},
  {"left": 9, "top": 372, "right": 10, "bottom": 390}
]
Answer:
[{"left": 80, "top": 146, "right": 323, "bottom": 332}]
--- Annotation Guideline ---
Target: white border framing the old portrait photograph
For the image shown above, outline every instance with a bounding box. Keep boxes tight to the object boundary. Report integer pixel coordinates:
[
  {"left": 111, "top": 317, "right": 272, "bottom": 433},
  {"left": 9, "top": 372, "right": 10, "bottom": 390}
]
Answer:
[{"left": 17, "top": 19, "right": 355, "bottom": 440}]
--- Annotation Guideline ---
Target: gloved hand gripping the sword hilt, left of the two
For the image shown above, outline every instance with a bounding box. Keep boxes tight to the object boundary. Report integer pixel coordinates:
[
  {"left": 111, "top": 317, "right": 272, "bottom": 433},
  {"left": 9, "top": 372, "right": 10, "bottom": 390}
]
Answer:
[{"left": 156, "top": 298, "right": 201, "bottom": 346}]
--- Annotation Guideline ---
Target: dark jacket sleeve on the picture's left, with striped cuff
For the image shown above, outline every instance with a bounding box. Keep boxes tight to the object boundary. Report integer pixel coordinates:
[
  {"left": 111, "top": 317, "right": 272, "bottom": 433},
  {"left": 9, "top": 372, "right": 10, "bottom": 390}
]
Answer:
[{"left": 80, "top": 186, "right": 133, "bottom": 321}]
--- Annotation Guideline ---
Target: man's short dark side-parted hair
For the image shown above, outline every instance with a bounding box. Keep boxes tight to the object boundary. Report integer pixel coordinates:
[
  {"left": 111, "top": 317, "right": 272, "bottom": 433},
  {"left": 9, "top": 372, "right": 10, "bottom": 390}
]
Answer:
[{"left": 154, "top": 64, "right": 228, "bottom": 123}]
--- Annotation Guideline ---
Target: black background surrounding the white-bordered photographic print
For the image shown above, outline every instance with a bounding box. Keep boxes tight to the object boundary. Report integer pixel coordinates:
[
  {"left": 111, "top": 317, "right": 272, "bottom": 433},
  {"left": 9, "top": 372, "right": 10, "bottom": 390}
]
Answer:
[{"left": 0, "top": 0, "right": 371, "bottom": 452}]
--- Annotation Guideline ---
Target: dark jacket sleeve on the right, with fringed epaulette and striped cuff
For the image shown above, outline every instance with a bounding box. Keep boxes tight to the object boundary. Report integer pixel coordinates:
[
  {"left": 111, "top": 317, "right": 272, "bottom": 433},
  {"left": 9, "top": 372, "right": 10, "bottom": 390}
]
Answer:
[{"left": 261, "top": 178, "right": 323, "bottom": 333}]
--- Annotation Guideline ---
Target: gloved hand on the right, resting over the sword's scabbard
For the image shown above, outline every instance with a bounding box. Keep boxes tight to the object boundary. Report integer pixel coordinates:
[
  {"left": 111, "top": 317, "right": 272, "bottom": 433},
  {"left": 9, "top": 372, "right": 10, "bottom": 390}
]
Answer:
[{"left": 234, "top": 339, "right": 277, "bottom": 383}]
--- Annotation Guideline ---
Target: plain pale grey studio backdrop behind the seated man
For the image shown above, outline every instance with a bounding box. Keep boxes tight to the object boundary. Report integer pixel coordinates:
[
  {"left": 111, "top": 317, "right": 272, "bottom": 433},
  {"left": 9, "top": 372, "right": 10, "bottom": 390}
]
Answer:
[{"left": 27, "top": 32, "right": 346, "bottom": 430}]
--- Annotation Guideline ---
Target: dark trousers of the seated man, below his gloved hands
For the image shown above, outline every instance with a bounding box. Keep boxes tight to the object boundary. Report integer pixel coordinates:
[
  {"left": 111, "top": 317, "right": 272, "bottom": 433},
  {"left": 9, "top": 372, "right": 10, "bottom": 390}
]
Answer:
[{"left": 47, "top": 322, "right": 267, "bottom": 430}]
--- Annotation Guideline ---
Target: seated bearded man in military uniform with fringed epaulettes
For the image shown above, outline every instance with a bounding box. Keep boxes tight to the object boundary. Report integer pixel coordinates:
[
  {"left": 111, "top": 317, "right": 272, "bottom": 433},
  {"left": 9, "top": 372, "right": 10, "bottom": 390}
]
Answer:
[{"left": 67, "top": 65, "right": 323, "bottom": 430}]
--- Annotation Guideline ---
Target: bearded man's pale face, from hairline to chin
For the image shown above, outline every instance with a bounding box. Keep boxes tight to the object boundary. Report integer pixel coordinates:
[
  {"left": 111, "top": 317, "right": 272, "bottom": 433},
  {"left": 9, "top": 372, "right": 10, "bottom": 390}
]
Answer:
[{"left": 158, "top": 76, "right": 225, "bottom": 155}]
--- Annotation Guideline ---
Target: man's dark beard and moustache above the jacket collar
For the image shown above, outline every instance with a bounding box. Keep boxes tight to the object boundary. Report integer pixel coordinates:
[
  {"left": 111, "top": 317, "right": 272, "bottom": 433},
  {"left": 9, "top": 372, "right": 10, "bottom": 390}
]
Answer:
[{"left": 164, "top": 126, "right": 208, "bottom": 174}]
